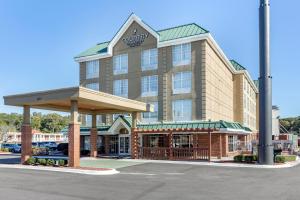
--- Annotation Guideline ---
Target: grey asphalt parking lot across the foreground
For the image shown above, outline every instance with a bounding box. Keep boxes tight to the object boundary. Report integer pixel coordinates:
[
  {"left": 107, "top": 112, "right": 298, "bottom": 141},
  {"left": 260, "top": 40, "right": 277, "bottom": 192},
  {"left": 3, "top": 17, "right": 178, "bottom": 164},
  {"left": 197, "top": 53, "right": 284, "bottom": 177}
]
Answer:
[{"left": 0, "top": 155, "right": 300, "bottom": 200}]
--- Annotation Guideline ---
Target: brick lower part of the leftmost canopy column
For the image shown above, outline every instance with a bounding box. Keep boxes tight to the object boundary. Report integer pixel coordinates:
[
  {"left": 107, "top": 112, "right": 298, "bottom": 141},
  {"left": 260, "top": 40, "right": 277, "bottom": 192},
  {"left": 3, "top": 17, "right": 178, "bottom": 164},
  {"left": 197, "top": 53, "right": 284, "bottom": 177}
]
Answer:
[{"left": 21, "top": 124, "right": 32, "bottom": 164}]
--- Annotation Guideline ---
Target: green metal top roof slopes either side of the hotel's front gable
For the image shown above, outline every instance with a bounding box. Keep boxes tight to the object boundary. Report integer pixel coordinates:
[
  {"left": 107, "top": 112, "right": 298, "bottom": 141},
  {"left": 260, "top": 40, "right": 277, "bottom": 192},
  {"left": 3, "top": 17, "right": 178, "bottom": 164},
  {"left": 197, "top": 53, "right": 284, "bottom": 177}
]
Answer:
[{"left": 75, "top": 23, "right": 209, "bottom": 58}]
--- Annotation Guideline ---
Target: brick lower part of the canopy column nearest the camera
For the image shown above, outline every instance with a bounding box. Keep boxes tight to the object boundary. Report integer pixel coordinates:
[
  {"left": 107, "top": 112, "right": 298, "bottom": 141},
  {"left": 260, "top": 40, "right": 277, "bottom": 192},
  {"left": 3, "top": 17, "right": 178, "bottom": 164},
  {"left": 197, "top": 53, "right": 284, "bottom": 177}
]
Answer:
[{"left": 69, "top": 123, "right": 80, "bottom": 167}]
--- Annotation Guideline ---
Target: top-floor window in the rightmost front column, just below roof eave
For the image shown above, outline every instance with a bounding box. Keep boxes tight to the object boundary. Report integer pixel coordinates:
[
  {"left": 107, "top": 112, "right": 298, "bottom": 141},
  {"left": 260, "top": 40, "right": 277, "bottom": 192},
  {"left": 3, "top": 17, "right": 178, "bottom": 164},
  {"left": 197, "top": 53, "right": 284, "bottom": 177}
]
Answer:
[{"left": 172, "top": 43, "right": 191, "bottom": 66}]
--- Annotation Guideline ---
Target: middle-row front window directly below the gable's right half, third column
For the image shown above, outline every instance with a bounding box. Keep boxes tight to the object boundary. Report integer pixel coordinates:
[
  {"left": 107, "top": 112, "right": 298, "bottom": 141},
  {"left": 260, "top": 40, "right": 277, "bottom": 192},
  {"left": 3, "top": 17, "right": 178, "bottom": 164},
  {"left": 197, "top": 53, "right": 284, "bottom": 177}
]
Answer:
[{"left": 142, "top": 75, "right": 158, "bottom": 97}]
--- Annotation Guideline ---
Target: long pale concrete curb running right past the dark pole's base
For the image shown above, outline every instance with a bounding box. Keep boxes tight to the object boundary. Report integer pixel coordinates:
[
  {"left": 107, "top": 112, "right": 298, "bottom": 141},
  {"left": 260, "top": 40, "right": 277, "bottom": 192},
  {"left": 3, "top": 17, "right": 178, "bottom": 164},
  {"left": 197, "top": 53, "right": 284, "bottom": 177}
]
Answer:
[{"left": 123, "top": 159, "right": 300, "bottom": 169}]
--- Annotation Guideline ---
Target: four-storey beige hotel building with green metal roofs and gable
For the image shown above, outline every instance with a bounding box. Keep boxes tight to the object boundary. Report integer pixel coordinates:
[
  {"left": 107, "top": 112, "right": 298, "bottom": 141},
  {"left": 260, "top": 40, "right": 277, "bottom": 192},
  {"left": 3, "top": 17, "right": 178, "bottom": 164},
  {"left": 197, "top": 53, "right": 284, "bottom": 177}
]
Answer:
[{"left": 75, "top": 14, "right": 258, "bottom": 159}]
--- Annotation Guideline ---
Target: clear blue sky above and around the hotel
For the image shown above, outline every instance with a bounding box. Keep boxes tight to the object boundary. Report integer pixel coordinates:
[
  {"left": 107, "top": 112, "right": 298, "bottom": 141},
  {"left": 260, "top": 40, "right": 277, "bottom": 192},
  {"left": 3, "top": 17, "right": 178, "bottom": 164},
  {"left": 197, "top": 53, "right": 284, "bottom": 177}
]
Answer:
[{"left": 0, "top": 0, "right": 300, "bottom": 117}]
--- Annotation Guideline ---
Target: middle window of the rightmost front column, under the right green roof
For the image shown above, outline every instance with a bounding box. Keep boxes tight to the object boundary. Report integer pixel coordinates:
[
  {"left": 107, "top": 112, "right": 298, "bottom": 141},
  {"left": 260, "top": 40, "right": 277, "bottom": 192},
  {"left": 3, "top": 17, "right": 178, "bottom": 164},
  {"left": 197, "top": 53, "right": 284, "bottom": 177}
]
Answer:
[{"left": 173, "top": 72, "right": 192, "bottom": 94}]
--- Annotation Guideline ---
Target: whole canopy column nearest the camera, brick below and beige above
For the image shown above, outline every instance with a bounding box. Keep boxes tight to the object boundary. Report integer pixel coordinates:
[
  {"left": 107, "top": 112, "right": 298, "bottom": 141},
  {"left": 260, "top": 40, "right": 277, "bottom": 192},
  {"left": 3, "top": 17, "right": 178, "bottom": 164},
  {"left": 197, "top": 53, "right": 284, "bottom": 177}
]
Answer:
[{"left": 69, "top": 100, "right": 80, "bottom": 167}]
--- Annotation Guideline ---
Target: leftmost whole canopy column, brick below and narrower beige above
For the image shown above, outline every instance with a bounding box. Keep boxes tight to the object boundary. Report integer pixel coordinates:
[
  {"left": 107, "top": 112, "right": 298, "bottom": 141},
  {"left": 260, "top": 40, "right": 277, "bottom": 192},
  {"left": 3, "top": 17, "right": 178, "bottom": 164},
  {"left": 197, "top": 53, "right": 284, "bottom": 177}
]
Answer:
[{"left": 21, "top": 106, "right": 32, "bottom": 164}]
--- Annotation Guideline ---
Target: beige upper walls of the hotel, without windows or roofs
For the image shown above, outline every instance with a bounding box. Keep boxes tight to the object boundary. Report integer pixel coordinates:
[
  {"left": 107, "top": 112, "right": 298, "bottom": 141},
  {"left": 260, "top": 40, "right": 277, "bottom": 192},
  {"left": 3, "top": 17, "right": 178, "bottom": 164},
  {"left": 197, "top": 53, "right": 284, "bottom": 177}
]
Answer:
[{"left": 79, "top": 15, "right": 258, "bottom": 131}]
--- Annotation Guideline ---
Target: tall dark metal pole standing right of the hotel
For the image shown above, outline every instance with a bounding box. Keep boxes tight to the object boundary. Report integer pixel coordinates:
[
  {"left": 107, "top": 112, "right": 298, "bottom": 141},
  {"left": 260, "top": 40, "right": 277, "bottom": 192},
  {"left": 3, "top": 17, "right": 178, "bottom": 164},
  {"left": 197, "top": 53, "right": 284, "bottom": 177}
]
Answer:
[{"left": 258, "top": 0, "right": 274, "bottom": 165}]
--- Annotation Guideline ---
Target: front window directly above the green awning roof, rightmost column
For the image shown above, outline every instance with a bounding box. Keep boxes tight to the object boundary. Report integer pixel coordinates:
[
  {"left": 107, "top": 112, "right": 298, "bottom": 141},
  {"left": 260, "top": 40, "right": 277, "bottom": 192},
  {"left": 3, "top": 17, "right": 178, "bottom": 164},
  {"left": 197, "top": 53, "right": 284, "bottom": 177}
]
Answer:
[{"left": 172, "top": 100, "right": 192, "bottom": 121}]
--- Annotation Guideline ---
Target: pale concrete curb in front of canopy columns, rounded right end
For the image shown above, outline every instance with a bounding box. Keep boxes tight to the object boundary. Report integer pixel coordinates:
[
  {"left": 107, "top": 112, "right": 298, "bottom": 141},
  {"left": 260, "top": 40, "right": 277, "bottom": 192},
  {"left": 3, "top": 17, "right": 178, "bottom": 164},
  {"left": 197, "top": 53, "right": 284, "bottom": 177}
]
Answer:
[{"left": 0, "top": 164, "right": 120, "bottom": 176}]
